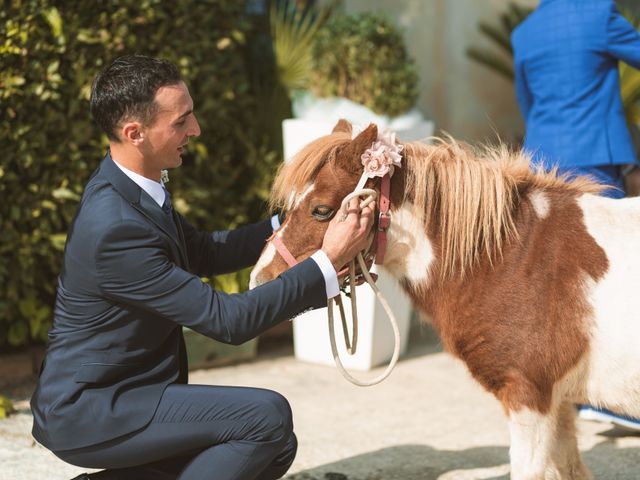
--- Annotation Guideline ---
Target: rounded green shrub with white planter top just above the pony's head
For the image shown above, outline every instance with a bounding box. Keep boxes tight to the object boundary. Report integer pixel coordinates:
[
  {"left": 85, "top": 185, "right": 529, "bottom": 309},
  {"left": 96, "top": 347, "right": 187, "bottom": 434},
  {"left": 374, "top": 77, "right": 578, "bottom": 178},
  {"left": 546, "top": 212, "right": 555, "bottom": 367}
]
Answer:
[{"left": 283, "top": 12, "right": 433, "bottom": 159}]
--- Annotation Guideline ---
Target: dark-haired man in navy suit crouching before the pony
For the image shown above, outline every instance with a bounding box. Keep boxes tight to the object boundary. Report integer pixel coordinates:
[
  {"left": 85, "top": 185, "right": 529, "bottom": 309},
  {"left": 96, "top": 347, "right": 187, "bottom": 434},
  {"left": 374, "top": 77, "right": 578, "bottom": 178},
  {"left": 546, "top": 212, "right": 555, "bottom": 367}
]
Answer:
[{"left": 31, "top": 55, "right": 373, "bottom": 480}]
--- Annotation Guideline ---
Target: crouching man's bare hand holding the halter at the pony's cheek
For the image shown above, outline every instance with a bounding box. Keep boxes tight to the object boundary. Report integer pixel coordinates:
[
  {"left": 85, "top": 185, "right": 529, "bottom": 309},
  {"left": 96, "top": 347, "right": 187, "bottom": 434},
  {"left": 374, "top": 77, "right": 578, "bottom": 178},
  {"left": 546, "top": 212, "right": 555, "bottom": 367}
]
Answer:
[{"left": 322, "top": 198, "right": 375, "bottom": 272}]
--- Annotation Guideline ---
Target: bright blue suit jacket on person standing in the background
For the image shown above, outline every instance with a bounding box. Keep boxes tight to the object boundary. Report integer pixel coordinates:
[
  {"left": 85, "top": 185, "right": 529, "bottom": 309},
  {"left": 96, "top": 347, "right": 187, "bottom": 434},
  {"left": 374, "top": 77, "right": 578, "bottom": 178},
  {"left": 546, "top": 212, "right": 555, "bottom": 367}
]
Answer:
[{"left": 511, "top": 0, "right": 640, "bottom": 168}]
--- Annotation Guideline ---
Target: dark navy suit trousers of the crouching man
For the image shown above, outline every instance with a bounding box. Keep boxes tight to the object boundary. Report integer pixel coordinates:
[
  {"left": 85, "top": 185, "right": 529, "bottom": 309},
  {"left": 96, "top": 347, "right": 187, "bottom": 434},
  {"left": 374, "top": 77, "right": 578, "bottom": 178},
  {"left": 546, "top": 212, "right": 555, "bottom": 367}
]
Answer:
[{"left": 54, "top": 384, "right": 297, "bottom": 480}]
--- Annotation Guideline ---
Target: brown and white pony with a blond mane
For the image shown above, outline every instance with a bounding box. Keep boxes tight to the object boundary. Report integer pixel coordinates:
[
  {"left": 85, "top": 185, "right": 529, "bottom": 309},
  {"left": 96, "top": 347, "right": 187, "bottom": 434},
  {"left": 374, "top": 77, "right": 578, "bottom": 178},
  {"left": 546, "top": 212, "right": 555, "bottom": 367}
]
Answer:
[{"left": 252, "top": 121, "right": 640, "bottom": 480}]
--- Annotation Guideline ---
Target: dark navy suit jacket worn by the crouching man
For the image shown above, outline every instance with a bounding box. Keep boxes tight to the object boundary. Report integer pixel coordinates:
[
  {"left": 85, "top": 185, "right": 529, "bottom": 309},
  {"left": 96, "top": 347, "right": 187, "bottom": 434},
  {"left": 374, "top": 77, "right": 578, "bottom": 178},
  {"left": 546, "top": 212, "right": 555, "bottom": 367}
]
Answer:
[{"left": 31, "top": 155, "right": 327, "bottom": 451}]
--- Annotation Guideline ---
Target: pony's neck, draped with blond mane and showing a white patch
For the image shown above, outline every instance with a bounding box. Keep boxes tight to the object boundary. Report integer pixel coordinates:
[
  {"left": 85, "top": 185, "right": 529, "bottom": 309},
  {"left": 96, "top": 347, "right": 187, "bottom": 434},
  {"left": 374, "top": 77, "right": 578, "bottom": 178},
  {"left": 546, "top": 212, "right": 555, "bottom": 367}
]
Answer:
[{"left": 384, "top": 139, "right": 516, "bottom": 288}]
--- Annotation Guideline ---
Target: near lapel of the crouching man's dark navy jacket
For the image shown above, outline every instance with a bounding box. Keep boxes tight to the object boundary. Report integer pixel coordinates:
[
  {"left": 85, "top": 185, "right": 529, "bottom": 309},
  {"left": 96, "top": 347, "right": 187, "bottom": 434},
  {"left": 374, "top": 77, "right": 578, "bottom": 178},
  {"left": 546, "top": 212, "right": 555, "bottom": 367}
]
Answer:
[{"left": 100, "top": 153, "right": 187, "bottom": 268}]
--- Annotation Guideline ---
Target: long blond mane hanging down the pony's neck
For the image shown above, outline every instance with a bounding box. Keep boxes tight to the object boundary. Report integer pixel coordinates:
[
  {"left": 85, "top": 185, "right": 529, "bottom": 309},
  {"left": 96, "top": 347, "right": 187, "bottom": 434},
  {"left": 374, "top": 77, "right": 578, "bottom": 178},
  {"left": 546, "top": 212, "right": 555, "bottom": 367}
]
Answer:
[{"left": 403, "top": 137, "right": 603, "bottom": 277}]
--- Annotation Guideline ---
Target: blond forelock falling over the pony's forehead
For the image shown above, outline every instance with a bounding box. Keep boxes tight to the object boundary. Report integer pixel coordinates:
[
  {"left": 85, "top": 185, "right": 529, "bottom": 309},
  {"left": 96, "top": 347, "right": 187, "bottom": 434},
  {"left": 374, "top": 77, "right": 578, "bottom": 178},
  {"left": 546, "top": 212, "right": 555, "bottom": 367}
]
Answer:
[{"left": 269, "top": 132, "right": 351, "bottom": 211}]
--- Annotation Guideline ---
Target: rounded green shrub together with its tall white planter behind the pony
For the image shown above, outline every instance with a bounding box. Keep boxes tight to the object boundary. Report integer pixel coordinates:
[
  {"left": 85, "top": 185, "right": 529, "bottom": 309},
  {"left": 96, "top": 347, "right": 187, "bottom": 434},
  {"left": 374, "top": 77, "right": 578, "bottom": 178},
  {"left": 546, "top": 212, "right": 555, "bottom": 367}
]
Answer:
[{"left": 273, "top": 7, "right": 433, "bottom": 370}]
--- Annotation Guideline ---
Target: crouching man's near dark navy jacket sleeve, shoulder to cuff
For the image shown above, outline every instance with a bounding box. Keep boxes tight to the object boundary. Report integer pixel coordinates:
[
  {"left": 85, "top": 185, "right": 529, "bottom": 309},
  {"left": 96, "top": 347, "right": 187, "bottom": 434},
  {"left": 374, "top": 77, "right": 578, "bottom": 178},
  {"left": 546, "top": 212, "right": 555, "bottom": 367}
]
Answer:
[{"left": 95, "top": 222, "right": 327, "bottom": 345}]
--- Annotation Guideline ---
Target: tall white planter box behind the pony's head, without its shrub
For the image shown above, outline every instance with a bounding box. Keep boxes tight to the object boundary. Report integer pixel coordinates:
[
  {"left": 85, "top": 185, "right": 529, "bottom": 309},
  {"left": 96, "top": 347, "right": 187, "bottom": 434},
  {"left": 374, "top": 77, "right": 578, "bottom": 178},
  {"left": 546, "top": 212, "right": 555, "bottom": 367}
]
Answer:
[{"left": 282, "top": 119, "right": 433, "bottom": 370}]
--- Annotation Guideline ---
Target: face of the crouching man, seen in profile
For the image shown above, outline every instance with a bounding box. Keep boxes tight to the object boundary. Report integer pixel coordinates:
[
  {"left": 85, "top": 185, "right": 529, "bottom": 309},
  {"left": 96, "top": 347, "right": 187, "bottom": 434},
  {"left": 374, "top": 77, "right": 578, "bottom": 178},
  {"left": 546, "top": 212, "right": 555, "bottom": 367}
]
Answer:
[{"left": 142, "top": 82, "right": 200, "bottom": 170}]
